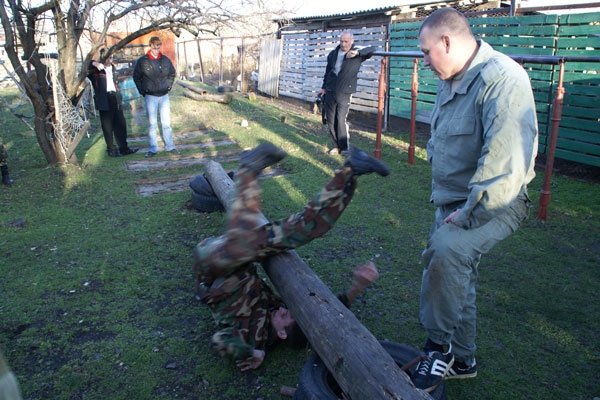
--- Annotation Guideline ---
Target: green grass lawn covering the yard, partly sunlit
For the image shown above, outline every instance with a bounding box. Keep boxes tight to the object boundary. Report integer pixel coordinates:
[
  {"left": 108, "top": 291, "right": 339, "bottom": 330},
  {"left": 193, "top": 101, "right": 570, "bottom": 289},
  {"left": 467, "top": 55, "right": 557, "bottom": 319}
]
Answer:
[{"left": 0, "top": 85, "right": 600, "bottom": 400}]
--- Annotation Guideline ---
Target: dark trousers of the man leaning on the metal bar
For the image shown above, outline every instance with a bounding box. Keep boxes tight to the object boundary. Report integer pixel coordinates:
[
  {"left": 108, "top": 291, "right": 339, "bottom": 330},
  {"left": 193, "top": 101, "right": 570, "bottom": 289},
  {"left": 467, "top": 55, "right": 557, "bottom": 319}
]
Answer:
[{"left": 325, "top": 92, "right": 352, "bottom": 151}]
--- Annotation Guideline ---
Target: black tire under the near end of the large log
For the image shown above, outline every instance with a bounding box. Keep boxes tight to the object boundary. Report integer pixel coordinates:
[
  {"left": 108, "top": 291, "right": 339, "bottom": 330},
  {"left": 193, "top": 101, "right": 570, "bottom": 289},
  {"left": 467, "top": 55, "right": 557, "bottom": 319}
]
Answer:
[{"left": 292, "top": 340, "right": 448, "bottom": 400}]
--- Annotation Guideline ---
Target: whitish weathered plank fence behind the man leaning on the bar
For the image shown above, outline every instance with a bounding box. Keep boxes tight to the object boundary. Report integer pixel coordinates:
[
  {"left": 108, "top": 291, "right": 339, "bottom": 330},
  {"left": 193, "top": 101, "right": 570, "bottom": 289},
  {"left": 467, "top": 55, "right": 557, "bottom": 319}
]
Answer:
[{"left": 279, "top": 26, "right": 387, "bottom": 113}]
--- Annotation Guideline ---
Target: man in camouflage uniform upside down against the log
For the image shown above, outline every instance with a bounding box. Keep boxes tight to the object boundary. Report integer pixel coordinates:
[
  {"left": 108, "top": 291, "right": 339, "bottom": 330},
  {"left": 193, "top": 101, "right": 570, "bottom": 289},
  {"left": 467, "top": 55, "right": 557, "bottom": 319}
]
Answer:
[{"left": 194, "top": 144, "right": 389, "bottom": 371}]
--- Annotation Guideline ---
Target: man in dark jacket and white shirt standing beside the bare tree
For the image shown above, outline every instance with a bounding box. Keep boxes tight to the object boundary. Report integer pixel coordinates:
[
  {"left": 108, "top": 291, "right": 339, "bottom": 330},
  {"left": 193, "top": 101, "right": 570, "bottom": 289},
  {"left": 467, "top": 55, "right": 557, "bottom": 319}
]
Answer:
[{"left": 88, "top": 49, "right": 139, "bottom": 157}]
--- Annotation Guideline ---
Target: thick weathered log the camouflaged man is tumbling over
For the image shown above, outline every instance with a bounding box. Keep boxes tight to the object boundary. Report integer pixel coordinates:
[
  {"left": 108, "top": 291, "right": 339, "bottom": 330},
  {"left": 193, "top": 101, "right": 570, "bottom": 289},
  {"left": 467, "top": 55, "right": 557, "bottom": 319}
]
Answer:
[{"left": 204, "top": 161, "right": 431, "bottom": 400}]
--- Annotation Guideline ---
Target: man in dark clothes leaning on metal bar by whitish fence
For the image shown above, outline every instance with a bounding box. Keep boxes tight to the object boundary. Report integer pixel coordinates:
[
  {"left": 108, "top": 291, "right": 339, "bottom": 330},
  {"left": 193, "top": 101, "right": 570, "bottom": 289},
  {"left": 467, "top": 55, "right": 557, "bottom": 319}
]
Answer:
[{"left": 319, "top": 32, "right": 375, "bottom": 154}]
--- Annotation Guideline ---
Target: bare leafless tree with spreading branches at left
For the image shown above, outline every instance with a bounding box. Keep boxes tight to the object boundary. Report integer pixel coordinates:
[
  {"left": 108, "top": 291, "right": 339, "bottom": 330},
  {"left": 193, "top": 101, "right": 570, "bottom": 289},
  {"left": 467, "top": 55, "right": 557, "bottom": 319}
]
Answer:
[{"left": 0, "top": 0, "right": 264, "bottom": 164}]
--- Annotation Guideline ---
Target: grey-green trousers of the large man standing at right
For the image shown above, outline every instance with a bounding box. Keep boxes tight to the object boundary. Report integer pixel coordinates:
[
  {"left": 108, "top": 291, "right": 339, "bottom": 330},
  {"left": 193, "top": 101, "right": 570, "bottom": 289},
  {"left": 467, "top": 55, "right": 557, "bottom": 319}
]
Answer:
[{"left": 419, "top": 193, "right": 530, "bottom": 365}]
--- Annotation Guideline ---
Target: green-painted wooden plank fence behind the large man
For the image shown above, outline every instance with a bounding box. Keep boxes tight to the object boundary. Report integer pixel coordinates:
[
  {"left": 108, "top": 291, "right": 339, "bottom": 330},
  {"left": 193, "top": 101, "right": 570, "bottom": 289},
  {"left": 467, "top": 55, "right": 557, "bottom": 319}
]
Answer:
[{"left": 389, "top": 13, "right": 600, "bottom": 166}]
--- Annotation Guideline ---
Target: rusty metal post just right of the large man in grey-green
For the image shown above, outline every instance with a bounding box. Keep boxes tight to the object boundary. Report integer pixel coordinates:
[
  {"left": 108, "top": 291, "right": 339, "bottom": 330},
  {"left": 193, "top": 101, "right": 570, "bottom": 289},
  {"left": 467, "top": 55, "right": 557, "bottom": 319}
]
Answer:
[{"left": 537, "top": 61, "right": 565, "bottom": 221}]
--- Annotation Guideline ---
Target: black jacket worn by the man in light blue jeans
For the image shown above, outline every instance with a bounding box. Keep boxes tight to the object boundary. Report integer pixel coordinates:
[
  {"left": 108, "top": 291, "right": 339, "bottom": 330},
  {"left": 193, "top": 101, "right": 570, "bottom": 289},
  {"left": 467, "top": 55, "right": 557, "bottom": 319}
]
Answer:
[{"left": 133, "top": 53, "right": 176, "bottom": 96}]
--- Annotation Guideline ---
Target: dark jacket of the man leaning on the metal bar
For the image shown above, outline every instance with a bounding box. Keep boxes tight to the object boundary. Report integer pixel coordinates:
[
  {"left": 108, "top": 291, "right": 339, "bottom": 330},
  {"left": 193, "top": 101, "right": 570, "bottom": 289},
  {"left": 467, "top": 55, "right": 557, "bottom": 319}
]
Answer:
[{"left": 321, "top": 45, "right": 376, "bottom": 99}]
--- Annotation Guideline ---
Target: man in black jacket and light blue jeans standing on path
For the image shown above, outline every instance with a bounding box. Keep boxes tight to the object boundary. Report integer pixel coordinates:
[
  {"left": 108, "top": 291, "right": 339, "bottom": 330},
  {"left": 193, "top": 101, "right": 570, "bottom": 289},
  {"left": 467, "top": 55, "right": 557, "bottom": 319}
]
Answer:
[{"left": 133, "top": 36, "right": 179, "bottom": 157}]
